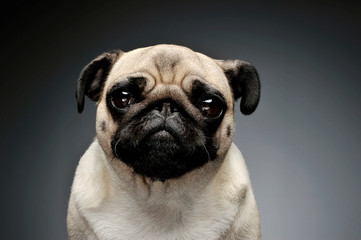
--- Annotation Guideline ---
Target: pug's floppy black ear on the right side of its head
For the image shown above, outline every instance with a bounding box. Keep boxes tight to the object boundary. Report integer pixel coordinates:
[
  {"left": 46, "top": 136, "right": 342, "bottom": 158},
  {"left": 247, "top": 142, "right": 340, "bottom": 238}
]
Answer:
[{"left": 216, "top": 60, "right": 261, "bottom": 115}]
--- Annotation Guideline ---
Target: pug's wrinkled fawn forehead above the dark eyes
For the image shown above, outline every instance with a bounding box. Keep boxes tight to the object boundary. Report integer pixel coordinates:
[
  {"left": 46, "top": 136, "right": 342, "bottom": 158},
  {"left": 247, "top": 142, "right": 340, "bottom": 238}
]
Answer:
[{"left": 107, "top": 45, "right": 230, "bottom": 92}]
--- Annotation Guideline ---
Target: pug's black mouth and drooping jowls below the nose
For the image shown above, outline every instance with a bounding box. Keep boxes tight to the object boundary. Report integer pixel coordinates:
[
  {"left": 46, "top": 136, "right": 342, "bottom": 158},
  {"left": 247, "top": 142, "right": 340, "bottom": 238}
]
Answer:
[{"left": 112, "top": 119, "right": 214, "bottom": 181}]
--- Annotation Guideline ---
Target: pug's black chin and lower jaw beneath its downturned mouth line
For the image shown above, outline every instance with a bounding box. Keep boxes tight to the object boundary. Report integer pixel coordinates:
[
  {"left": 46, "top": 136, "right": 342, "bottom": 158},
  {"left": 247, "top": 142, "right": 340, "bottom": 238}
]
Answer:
[{"left": 113, "top": 130, "right": 211, "bottom": 181}]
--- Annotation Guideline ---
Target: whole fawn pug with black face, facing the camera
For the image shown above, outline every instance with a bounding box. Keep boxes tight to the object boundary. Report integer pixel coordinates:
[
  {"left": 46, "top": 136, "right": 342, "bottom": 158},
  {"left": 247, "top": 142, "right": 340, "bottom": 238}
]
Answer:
[{"left": 67, "top": 45, "right": 261, "bottom": 240}]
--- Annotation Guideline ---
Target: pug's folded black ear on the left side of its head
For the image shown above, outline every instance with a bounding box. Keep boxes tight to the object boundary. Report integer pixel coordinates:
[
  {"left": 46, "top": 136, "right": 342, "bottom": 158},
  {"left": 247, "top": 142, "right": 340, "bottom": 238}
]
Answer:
[{"left": 76, "top": 50, "right": 123, "bottom": 113}]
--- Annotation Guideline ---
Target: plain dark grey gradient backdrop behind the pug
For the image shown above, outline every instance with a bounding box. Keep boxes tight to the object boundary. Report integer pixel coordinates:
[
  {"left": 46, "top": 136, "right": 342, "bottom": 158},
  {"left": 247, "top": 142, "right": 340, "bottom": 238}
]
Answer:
[{"left": 0, "top": 1, "right": 361, "bottom": 240}]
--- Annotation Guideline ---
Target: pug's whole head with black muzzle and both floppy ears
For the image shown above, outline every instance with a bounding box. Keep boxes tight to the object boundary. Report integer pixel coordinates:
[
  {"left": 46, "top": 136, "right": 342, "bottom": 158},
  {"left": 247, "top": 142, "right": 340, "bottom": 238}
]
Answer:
[{"left": 77, "top": 45, "right": 260, "bottom": 181}]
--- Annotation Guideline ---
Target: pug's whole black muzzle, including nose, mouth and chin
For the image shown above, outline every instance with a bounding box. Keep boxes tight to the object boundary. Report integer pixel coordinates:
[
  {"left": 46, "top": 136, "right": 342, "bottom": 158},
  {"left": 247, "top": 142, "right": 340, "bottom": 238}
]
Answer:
[{"left": 111, "top": 99, "right": 218, "bottom": 180}]
